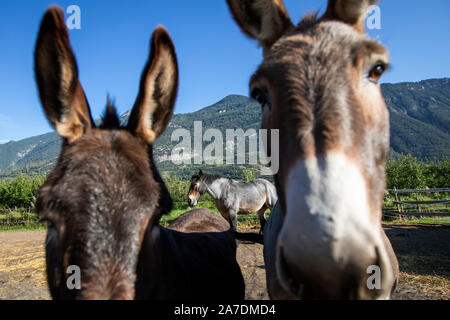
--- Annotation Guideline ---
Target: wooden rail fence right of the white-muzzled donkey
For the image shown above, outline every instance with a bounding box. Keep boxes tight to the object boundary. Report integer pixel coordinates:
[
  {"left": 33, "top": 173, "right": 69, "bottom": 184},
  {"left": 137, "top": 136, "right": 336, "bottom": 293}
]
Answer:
[{"left": 383, "top": 188, "right": 450, "bottom": 224}]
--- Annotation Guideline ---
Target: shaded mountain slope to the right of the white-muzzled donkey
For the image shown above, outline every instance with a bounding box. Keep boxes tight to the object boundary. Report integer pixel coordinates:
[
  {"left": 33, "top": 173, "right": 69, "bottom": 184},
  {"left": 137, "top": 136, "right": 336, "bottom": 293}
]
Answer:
[{"left": 382, "top": 78, "right": 450, "bottom": 159}]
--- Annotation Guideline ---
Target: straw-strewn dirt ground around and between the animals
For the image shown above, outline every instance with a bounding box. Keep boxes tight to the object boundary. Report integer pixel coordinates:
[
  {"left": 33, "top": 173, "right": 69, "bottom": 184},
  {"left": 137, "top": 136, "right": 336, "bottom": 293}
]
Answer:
[{"left": 0, "top": 225, "right": 450, "bottom": 300}]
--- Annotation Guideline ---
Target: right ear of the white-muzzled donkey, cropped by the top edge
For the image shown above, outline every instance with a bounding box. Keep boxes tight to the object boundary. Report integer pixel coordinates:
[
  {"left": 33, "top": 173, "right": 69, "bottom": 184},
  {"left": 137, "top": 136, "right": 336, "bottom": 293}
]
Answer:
[{"left": 323, "top": 0, "right": 378, "bottom": 33}]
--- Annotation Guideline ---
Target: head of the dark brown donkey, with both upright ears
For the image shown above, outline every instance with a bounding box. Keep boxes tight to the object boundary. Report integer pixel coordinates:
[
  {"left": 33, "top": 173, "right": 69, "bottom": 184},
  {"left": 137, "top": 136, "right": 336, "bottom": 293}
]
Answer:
[{"left": 34, "top": 7, "right": 178, "bottom": 299}]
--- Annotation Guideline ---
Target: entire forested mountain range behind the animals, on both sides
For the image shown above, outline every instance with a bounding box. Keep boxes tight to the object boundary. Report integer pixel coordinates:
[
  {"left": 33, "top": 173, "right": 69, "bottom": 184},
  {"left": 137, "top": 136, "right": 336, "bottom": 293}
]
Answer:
[{"left": 0, "top": 78, "right": 450, "bottom": 177}]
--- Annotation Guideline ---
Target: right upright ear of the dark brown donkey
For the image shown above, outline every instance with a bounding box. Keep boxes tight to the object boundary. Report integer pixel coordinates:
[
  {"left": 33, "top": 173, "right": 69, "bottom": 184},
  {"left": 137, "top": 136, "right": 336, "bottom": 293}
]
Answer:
[{"left": 127, "top": 26, "right": 178, "bottom": 144}]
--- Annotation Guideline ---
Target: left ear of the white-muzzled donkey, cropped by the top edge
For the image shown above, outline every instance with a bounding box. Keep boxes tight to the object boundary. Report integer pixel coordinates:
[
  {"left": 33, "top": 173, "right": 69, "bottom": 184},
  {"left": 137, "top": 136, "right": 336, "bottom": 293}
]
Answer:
[{"left": 227, "top": 0, "right": 293, "bottom": 50}]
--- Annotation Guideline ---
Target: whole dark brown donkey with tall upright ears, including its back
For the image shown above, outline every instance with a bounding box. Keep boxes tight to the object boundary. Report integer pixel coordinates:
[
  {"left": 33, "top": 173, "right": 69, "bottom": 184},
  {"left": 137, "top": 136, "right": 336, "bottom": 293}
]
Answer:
[{"left": 35, "top": 7, "right": 244, "bottom": 300}]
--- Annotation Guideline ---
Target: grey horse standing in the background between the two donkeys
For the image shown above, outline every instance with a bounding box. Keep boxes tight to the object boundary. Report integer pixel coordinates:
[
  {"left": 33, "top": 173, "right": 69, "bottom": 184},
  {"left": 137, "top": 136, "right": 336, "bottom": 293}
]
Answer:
[{"left": 188, "top": 170, "right": 278, "bottom": 233}]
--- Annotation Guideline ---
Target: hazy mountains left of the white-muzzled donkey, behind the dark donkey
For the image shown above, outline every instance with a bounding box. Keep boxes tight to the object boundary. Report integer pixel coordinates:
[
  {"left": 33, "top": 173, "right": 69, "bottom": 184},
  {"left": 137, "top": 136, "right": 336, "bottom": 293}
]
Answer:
[{"left": 0, "top": 95, "right": 260, "bottom": 177}]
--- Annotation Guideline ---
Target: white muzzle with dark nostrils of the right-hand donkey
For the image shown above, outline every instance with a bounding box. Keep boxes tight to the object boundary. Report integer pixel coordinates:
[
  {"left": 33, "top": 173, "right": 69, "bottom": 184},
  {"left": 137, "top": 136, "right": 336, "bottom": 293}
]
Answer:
[{"left": 276, "top": 154, "right": 393, "bottom": 299}]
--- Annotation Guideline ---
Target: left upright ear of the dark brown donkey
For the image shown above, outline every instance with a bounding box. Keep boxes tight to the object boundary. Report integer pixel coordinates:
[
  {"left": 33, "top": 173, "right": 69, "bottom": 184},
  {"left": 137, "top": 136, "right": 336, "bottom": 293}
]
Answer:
[{"left": 34, "top": 6, "right": 93, "bottom": 143}]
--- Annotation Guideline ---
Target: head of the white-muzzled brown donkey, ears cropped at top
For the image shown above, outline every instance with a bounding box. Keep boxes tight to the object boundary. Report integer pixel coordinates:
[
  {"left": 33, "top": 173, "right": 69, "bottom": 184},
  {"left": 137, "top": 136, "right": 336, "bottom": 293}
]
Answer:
[{"left": 228, "top": 0, "right": 398, "bottom": 299}]
